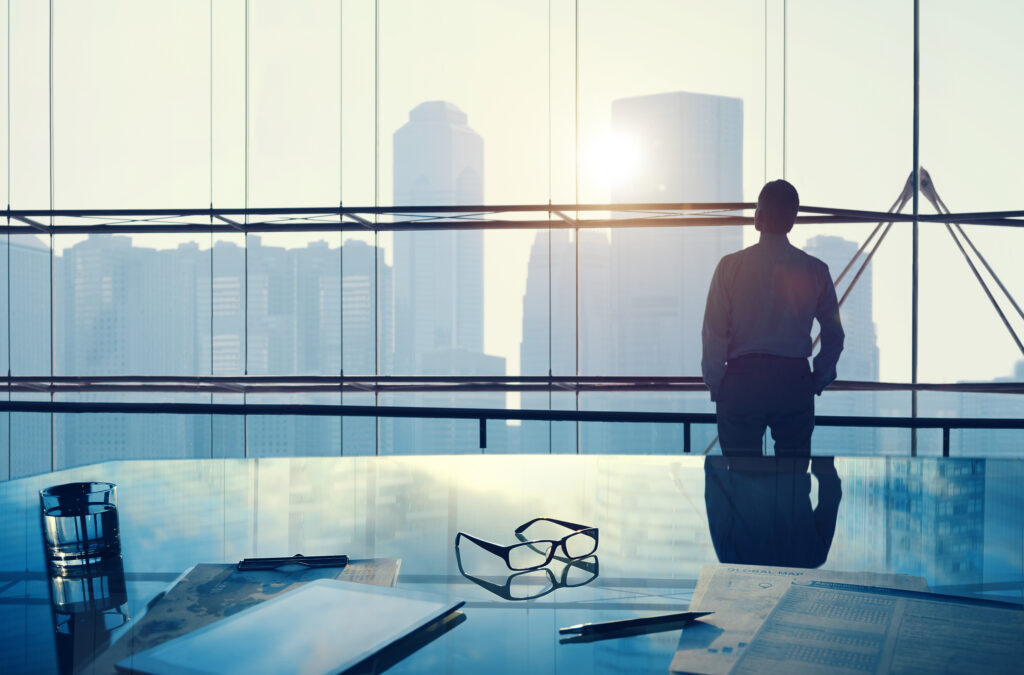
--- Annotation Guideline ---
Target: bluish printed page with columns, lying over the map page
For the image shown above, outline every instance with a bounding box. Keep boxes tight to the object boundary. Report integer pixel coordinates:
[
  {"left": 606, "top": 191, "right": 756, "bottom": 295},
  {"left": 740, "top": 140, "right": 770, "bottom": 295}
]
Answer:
[{"left": 732, "top": 581, "right": 1024, "bottom": 675}]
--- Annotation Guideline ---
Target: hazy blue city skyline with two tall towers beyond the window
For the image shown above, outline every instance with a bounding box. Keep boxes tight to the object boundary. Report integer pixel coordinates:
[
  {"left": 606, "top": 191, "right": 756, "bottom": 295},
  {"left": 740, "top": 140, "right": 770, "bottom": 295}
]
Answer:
[{"left": 0, "top": 80, "right": 1020, "bottom": 456}]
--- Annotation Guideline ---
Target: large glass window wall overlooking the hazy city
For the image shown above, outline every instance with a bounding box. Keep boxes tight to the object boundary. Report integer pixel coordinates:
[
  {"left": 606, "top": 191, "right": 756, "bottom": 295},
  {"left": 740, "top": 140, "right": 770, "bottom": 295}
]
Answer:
[{"left": 0, "top": 0, "right": 1024, "bottom": 477}]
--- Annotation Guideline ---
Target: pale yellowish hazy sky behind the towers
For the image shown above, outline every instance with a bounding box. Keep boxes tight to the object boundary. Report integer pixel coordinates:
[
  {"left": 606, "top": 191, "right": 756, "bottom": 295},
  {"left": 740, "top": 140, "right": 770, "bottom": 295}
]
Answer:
[{"left": 0, "top": 0, "right": 1024, "bottom": 381}]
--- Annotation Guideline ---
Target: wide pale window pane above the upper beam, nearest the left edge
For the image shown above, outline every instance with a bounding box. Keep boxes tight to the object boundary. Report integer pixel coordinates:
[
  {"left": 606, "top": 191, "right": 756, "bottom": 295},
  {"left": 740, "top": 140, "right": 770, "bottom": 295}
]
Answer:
[{"left": 52, "top": 0, "right": 210, "bottom": 209}]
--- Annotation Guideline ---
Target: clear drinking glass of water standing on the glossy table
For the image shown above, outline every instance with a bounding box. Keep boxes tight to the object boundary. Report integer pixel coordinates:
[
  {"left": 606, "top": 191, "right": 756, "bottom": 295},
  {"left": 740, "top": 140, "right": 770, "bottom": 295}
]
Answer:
[{"left": 39, "top": 482, "right": 121, "bottom": 566}]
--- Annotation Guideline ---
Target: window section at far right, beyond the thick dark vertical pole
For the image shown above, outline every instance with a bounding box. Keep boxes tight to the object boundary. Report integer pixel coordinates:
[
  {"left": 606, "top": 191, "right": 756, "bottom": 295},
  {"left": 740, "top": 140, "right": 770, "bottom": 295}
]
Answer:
[{"left": 920, "top": 2, "right": 1024, "bottom": 456}]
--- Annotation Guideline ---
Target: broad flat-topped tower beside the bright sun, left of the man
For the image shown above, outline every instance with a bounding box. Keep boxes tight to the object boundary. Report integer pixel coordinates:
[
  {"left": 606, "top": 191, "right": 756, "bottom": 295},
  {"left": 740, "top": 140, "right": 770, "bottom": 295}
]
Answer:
[{"left": 588, "top": 91, "right": 743, "bottom": 452}]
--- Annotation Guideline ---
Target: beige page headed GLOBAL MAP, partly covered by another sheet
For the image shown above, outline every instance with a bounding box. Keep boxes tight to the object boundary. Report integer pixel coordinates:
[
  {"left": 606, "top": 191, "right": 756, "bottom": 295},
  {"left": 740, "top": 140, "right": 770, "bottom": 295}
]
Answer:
[{"left": 671, "top": 564, "right": 928, "bottom": 675}]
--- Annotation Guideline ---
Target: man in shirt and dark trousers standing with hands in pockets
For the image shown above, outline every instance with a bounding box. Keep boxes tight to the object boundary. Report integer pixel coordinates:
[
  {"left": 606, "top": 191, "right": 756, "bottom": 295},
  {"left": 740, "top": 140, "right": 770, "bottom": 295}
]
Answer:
[{"left": 700, "top": 180, "right": 845, "bottom": 456}]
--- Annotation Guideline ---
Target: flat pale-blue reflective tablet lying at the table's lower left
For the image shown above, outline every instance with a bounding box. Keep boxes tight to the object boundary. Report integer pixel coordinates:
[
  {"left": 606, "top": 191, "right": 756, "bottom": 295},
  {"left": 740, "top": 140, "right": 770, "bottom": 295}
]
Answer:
[{"left": 118, "top": 580, "right": 463, "bottom": 674}]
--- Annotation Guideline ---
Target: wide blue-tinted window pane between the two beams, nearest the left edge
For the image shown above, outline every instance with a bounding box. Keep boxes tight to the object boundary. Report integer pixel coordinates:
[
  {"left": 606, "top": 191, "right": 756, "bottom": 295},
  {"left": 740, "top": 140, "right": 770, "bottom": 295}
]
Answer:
[{"left": 53, "top": 235, "right": 210, "bottom": 375}]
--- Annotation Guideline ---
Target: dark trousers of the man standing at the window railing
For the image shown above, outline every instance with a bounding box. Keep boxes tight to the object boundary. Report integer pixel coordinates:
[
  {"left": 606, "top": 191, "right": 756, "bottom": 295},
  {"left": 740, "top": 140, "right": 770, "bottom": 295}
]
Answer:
[{"left": 718, "top": 354, "right": 814, "bottom": 457}]
